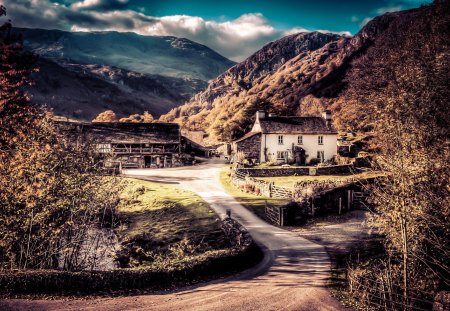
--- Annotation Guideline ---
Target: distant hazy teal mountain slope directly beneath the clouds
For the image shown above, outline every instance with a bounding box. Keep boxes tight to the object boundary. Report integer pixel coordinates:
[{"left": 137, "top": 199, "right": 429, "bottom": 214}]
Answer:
[{"left": 15, "top": 28, "right": 235, "bottom": 81}]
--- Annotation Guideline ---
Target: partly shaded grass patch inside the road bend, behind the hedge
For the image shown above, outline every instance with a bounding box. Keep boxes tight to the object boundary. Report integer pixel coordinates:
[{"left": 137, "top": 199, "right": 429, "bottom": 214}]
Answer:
[{"left": 118, "top": 179, "right": 229, "bottom": 267}]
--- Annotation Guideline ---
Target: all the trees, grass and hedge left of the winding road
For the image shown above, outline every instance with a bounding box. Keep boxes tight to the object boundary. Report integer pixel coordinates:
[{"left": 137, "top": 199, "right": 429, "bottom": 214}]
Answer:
[{"left": 0, "top": 9, "right": 261, "bottom": 295}]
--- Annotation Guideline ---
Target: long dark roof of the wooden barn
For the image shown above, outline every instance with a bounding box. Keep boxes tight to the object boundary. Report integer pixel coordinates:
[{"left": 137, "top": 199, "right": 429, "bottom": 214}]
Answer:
[{"left": 53, "top": 122, "right": 180, "bottom": 144}]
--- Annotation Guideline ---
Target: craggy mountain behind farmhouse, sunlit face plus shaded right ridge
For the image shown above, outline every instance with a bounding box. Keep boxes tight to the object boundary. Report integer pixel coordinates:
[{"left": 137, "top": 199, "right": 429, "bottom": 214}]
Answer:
[{"left": 161, "top": 8, "right": 434, "bottom": 142}]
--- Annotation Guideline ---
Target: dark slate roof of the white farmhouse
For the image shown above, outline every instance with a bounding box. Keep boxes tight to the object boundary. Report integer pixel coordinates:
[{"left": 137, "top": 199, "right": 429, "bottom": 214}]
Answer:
[{"left": 259, "top": 116, "right": 338, "bottom": 134}]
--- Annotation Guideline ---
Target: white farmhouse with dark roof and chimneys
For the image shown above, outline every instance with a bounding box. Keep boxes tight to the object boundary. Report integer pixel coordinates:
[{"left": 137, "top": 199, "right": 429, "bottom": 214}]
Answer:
[{"left": 233, "top": 110, "right": 337, "bottom": 165}]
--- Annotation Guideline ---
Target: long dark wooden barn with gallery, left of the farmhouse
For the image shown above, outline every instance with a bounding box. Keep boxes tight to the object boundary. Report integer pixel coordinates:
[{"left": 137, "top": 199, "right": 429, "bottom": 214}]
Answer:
[{"left": 58, "top": 122, "right": 183, "bottom": 169}]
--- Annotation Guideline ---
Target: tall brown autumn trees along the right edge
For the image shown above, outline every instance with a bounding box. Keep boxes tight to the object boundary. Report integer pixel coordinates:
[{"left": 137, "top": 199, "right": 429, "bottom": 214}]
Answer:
[{"left": 337, "top": 1, "right": 450, "bottom": 309}]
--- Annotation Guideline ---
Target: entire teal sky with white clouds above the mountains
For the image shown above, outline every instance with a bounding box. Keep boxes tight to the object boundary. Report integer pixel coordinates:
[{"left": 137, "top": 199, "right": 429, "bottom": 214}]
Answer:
[{"left": 0, "top": 0, "right": 431, "bottom": 61}]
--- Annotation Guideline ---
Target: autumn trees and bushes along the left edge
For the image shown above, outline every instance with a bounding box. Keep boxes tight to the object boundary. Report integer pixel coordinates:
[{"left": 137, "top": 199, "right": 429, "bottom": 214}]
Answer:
[{"left": 0, "top": 7, "right": 117, "bottom": 270}]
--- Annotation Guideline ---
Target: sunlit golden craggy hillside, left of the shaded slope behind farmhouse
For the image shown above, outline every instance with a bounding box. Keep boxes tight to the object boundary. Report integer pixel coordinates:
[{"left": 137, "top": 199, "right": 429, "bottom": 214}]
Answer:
[{"left": 161, "top": 32, "right": 349, "bottom": 141}]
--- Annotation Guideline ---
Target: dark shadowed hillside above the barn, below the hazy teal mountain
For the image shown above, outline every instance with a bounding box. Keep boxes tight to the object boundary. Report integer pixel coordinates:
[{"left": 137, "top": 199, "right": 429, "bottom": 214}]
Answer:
[{"left": 28, "top": 58, "right": 207, "bottom": 121}]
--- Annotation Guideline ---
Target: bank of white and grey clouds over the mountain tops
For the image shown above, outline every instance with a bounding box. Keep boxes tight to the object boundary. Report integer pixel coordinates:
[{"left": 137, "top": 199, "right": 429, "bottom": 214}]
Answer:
[{"left": 0, "top": 0, "right": 350, "bottom": 61}]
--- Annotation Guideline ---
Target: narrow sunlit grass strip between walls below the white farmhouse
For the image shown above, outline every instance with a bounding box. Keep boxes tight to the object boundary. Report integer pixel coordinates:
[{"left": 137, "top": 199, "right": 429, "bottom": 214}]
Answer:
[{"left": 257, "top": 172, "right": 383, "bottom": 188}]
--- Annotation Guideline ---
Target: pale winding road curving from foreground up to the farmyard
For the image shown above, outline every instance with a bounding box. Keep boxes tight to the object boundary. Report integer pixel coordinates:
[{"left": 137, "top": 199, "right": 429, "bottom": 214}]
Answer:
[{"left": 0, "top": 160, "right": 346, "bottom": 311}]
